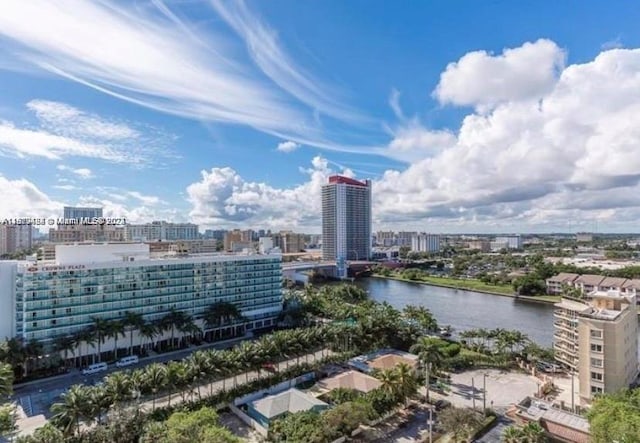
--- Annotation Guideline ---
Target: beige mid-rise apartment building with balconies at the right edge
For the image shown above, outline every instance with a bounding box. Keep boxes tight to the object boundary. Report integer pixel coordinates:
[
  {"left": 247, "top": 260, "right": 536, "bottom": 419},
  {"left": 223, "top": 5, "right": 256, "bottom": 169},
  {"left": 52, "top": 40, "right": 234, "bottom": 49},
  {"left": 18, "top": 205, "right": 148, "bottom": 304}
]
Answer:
[{"left": 553, "top": 290, "right": 638, "bottom": 404}]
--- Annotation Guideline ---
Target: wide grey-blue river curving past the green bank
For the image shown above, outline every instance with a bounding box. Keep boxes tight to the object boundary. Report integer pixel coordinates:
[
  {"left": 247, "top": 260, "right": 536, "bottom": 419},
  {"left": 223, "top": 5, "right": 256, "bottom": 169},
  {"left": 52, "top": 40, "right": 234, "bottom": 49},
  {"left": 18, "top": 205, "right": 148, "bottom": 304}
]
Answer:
[{"left": 355, "top": 277, "right": 553, "bottom": 347}]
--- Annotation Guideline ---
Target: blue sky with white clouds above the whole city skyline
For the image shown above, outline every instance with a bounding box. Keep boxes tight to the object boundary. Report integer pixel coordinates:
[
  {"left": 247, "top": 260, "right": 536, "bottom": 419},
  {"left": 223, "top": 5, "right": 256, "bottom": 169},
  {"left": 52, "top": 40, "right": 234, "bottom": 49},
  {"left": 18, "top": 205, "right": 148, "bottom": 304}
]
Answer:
[{"left": 0, "top": 0, "right": 640, "bottom": 232}]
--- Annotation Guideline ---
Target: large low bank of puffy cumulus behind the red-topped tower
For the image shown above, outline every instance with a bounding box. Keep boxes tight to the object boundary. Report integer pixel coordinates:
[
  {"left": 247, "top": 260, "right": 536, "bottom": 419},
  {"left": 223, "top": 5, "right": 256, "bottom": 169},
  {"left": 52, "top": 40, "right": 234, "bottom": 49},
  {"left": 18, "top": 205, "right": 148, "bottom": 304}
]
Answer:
[{"left": 188, "top": 43, "right": 640, "bottom": 232}]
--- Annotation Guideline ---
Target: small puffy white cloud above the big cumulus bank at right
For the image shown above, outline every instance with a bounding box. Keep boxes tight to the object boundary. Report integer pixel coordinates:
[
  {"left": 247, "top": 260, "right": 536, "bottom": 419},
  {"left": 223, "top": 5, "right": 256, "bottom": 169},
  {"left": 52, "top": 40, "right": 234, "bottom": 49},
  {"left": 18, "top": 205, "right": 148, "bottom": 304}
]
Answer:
[{"left": 433, "top": 39, "right": 565, "bottom": 110}]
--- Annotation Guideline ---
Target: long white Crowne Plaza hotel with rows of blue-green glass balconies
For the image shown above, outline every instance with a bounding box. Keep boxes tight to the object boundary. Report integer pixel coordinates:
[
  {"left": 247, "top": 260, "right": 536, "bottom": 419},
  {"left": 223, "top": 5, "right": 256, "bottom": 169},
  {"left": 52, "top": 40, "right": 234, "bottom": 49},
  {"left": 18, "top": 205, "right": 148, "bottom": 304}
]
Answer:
[{"left": 0, "top": 243, "right": 282, "bottom": 354}]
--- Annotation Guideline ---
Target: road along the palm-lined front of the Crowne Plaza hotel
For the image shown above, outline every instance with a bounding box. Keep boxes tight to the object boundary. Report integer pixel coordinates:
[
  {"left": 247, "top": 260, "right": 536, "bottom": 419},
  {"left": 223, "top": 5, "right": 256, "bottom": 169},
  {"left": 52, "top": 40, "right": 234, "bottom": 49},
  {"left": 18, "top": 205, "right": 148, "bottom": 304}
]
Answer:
[{"left": 13, "top": 336, "right": 253, "bottom": 416}]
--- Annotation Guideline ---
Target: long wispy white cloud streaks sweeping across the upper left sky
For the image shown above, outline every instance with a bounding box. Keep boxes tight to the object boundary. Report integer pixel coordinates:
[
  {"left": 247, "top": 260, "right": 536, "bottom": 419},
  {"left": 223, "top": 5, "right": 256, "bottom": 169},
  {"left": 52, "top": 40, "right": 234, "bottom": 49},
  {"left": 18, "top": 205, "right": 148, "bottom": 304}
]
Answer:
[{"left": 0, "top": 0, "right": 384, "bottom": 158}]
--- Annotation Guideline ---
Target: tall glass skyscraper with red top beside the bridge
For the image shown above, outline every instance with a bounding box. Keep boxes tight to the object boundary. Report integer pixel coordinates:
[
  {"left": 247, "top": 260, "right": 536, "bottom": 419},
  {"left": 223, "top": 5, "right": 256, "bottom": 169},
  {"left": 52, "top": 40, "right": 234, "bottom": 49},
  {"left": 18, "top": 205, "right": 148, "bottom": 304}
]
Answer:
[{"left": 322, "top": 175, "right": 371, "bottom": 261}]
